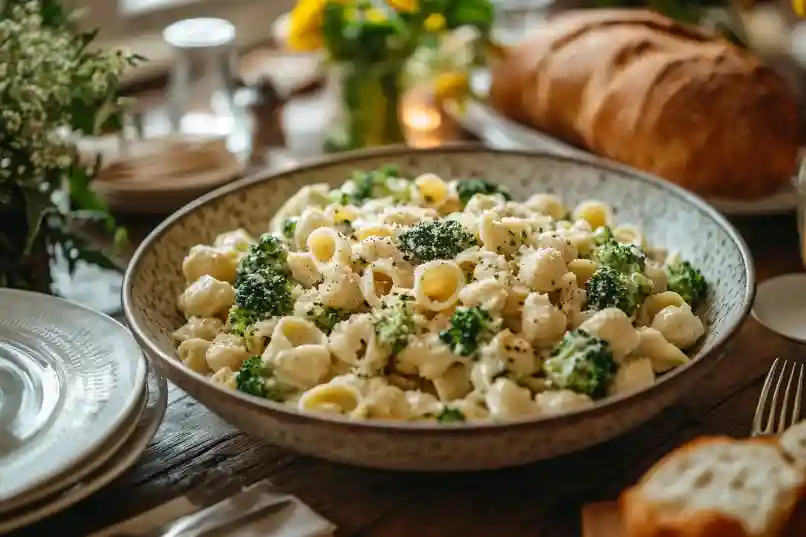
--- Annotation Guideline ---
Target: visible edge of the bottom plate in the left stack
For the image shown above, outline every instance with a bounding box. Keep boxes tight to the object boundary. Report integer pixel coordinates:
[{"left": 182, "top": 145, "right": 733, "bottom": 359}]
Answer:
[{"left": 0, "top": 358, "right": 168, "bottom": 534}]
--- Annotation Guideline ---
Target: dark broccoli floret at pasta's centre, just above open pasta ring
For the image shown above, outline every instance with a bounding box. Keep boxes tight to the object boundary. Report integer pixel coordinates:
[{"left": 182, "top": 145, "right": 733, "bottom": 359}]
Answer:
[{"left": 398, "top": 220, "right": 476, "bottom": 262}]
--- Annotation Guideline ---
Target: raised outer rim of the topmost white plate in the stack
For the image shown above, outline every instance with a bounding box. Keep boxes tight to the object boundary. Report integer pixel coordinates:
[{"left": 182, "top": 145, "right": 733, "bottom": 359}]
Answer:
[{"left": 0, "top": 288, "right": 148, "bottom": 502}]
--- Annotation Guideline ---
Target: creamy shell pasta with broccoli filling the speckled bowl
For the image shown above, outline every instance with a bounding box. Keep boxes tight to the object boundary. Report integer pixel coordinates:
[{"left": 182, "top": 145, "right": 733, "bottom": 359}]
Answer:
[{"left": 174, "top": 167, "right": 707, "bottom": 424}]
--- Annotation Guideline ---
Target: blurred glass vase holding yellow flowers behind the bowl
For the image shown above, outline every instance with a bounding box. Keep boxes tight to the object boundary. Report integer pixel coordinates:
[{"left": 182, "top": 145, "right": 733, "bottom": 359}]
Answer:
[{"left": 325, "top": 61, "right": 406, "bottom": 152}]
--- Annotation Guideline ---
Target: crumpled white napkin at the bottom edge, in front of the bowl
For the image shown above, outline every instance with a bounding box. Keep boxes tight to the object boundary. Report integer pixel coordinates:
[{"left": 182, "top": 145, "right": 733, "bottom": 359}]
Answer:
[{"left": 89, "top": 480, "right": 336, "bottom": 537}]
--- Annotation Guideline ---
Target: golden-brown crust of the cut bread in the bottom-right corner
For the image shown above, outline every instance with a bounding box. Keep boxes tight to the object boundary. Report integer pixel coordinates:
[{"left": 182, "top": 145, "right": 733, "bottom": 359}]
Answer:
[{"left": 619, "top": 436, "right": 803, "bottom": 537}]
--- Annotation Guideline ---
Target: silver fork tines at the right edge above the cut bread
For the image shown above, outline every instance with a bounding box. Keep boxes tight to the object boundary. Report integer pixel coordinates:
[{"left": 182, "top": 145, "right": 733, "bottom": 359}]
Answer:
[{"left": 750, "top": 358, "right": 803, "bottom": 436}]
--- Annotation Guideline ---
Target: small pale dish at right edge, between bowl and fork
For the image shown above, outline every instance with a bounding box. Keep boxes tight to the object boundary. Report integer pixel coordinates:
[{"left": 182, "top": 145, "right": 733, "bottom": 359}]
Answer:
[{"left": 751, "top": 273, "right": 806, "bottom": 343}]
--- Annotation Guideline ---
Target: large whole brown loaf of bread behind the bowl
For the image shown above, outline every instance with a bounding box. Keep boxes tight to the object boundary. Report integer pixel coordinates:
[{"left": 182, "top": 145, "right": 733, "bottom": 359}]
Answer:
[{"left": 489, "top": 9, "right": 799, "bottom": 199}]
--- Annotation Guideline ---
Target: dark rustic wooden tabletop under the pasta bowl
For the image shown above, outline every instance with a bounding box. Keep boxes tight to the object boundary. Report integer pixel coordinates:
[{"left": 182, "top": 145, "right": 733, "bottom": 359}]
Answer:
[{"left": 9, "top": 59, "right": 802, "bottom": 537}]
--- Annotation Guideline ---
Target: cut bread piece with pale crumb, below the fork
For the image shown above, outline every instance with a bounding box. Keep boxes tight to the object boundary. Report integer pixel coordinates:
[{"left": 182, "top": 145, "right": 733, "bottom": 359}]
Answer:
[{"left": 620, "top": 436, "right": 806, "bottom": 537}]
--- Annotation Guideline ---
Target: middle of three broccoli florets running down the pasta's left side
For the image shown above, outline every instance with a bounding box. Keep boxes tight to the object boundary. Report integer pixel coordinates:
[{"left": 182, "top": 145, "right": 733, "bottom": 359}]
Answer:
[{"left": 228, "top": 267, "right": 294, "bottom": 335}]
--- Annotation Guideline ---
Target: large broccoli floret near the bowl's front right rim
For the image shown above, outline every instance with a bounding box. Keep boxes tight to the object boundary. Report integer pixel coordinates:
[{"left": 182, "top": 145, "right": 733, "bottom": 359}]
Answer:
[{"left": 543, "top": 329, "right": 617, "bottom": 398}]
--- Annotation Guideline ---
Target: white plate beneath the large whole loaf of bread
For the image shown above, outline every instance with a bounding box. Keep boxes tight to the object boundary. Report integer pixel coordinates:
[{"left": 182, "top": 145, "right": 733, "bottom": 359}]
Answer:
[{"left": 445, "top": 70, "right": 806, "bottom": 216}]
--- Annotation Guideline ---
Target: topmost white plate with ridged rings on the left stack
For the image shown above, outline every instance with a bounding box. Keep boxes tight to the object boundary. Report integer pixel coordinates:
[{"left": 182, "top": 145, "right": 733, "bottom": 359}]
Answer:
[{"left": 0, "top": 289, "right": 146, "bottom": 505}]
